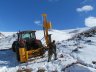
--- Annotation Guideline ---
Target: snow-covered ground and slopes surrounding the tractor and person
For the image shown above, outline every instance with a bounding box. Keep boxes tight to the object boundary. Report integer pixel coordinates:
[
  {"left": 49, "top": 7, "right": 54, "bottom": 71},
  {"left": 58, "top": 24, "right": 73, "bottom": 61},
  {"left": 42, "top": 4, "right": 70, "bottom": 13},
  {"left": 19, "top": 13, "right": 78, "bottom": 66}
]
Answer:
[{"left": 0, "top": 28, "right": 96, "bottom": 72}]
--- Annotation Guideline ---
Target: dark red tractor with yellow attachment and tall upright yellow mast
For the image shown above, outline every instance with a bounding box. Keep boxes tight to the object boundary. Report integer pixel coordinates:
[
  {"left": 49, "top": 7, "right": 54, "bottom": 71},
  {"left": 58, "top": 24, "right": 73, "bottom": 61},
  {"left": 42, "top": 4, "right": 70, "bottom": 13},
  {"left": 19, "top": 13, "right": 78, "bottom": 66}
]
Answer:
[{"left": 12, "top": 14, "right": 52, "bottom": 63}]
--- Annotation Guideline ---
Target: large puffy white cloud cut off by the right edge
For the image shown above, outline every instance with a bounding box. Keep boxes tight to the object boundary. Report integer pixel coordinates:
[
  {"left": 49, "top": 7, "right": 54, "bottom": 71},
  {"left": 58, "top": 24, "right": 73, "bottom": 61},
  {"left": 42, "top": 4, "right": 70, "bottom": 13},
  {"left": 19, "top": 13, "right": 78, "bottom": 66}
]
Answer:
[{"left": 85, "top": 16, "right": 96, "bottom": 27}]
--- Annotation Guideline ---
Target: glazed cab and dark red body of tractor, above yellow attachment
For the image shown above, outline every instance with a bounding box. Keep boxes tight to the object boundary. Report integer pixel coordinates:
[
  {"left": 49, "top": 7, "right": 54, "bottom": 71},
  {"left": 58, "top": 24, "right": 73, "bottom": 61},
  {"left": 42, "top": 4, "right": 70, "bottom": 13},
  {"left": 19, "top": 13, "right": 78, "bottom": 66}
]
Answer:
[{"left": 18, "top": 31, "right": 42, "bottom": 50}]
